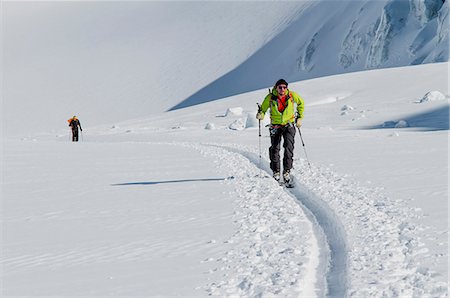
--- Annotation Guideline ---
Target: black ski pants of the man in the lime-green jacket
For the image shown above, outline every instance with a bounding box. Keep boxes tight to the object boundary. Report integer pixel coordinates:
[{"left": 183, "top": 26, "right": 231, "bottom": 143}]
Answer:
[{"left": 269, "top": 123, "right": 295, "bottom": 172}]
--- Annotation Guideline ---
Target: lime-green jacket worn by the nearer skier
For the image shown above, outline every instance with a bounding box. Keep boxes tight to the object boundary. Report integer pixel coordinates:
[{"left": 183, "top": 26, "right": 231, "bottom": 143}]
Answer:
[{"left": 260, "top": 88, "right": 305, "bottom": 125}]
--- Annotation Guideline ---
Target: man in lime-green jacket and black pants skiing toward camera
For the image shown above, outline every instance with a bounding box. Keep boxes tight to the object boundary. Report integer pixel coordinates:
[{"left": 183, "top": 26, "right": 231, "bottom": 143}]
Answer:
[{"left": 256, "top": 79, "right": 304, "bottom": 185}]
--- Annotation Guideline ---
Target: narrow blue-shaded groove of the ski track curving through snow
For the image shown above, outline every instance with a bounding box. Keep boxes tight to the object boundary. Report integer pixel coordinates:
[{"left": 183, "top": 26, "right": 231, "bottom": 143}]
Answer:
[{"left": 200, "top": 145, "right": 348, "bottom": 297}]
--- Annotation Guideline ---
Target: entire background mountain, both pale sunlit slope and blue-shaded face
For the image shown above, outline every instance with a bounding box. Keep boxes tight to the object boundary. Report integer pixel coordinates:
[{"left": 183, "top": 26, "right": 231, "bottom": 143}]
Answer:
[{"left": 1, "top": 0, "right": 450, "bottom": 136}]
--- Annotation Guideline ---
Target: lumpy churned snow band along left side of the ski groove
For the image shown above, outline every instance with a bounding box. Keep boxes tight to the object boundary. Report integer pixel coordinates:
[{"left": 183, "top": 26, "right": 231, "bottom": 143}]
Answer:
[{"left": 186, "top": 144, "right": 328, "bottom": 297}]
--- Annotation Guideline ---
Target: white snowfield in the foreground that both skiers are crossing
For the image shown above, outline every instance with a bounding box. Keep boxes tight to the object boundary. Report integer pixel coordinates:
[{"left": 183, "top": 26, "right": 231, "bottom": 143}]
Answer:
[{"left": 1, "top": 63, "right": 449, "bottom": 297}]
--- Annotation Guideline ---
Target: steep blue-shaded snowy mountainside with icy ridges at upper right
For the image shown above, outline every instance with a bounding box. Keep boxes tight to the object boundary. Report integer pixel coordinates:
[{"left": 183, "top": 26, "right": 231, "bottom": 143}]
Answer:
[{"left": 174, "top": 0, "right": 450, "bottom": 109}]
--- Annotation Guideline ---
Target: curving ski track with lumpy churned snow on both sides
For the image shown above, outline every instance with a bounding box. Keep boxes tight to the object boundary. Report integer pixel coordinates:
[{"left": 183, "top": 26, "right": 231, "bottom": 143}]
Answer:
[{"left": 185, "top": 144, "right": 447, "bottom": 297}]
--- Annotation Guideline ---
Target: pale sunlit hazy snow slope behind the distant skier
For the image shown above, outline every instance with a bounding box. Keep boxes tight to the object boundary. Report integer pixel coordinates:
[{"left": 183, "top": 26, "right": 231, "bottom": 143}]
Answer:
[{"left": 2, "top": 1, "right": 302, "bottom": 135}]
